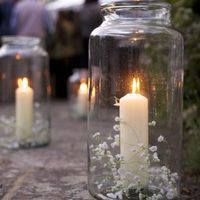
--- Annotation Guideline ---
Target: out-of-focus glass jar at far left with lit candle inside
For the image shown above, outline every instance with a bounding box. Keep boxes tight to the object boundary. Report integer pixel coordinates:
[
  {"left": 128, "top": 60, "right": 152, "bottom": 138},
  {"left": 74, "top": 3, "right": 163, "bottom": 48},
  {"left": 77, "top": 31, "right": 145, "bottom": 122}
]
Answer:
[{"left": 0, "top": 37, "right": 50, "bottom": 148}]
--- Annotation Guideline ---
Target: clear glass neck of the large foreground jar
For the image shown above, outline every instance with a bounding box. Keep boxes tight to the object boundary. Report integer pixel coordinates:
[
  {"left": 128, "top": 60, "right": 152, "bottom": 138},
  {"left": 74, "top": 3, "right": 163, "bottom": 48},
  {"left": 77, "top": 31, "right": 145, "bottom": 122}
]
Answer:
[{"left": 102, "top": 0, "right": 171, "bottom": 26}]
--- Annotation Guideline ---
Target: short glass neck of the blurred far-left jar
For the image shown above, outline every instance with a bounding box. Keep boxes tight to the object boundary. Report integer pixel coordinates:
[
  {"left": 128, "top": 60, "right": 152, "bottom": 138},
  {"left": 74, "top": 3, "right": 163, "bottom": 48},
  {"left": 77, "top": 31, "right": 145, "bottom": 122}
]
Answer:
[{"left": 2, "top": 36, "right": 40, "bottom": 49}]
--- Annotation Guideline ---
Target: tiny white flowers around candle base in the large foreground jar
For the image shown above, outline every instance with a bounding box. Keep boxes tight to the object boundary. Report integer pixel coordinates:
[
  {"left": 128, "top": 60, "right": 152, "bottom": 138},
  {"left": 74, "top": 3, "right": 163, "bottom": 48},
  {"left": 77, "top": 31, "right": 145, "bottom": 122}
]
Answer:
[{"left": 89, "top": 117, "right": 179, "bottom": 200}]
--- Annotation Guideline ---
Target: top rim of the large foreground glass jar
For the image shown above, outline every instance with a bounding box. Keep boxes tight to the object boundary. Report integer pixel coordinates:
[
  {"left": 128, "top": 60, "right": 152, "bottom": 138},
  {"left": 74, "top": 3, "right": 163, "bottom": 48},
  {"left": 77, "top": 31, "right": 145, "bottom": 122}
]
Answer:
[{"left": 101, "top": 0, "right": 171, "bottom": 11}]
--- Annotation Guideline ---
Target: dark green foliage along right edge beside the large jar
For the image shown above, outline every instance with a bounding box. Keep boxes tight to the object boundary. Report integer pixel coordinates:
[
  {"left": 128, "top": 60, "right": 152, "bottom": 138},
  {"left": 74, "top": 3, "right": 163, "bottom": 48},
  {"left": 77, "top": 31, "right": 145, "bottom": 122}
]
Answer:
[{"left": 168, "top": 0, "right": 200, "bottom": 173}]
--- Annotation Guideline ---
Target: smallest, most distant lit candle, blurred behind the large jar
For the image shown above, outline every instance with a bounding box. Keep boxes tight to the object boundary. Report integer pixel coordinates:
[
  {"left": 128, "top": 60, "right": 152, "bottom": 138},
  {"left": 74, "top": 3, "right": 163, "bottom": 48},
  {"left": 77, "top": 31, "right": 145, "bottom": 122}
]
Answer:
[{"left": 77, "top": 83, "right": 88, "bottom": 116}]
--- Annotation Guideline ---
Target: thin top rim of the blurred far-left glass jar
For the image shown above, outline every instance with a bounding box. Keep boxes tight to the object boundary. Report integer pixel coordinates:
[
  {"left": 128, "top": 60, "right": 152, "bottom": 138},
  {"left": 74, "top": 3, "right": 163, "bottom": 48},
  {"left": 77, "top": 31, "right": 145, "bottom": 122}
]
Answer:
[{"left": 2, "top": 36, "right": 41, "bottom": 46}]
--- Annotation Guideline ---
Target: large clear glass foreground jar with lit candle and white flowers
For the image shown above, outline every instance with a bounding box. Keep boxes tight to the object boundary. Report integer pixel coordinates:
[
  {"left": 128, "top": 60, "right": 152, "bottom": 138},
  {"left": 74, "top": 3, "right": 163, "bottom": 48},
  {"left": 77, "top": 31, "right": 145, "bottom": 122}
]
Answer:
[{"left": 88, "top": 0, "right": 183, "bottom": 200}]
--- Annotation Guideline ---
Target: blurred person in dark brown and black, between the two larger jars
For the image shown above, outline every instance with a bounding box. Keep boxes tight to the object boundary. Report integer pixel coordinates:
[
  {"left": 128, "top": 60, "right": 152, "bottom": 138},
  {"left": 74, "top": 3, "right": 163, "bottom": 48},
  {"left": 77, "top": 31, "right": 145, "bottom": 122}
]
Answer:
[{"left": 50, "top": 10, "right": 81, "bottom": 98}]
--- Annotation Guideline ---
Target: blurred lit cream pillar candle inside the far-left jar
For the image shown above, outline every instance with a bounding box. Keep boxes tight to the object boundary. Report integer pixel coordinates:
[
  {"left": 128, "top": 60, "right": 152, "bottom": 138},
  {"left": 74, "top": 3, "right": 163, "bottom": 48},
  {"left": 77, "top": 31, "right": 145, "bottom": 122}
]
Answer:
[{"left": 15, "top": 78, "right": 34, "bottom": 142}]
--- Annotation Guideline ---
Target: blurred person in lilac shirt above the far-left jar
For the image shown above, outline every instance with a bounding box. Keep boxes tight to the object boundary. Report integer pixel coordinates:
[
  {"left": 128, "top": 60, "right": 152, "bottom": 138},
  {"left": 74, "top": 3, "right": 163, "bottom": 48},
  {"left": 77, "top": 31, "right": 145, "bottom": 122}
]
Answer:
[{"left": 11, "top": 0, "right": 54, "bottom": 47}]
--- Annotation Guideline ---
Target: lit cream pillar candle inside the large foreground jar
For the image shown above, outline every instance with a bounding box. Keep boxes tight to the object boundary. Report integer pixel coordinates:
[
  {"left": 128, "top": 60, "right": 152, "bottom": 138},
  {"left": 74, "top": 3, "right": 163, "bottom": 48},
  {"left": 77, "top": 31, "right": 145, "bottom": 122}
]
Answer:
[{"left": 120, "top": 79, "right": 148, "bottom": 187}]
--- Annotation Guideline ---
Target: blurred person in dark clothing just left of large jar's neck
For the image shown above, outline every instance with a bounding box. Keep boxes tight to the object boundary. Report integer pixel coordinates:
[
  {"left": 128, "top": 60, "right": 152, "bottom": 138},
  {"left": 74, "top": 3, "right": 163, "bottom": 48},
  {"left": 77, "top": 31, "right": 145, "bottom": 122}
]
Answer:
[{"left": 80, "top": 0, "right": 102, "bottom": 68}]
